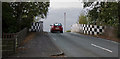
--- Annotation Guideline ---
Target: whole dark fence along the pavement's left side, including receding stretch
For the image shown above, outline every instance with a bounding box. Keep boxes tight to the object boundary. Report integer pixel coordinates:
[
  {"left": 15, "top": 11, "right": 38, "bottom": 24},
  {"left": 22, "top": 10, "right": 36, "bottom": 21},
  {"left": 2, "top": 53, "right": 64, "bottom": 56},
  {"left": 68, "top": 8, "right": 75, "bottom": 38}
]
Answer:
[{"left": 2, "top": 28, "right": 27, "bottom": 57}]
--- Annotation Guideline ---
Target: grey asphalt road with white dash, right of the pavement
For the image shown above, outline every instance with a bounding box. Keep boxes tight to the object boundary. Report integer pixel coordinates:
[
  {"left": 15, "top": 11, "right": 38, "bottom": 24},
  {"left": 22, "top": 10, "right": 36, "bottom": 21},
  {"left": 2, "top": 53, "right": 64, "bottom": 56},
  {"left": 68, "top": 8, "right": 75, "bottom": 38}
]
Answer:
[{"left": 48, "top": 33, "right": 118, "bottom": 57}]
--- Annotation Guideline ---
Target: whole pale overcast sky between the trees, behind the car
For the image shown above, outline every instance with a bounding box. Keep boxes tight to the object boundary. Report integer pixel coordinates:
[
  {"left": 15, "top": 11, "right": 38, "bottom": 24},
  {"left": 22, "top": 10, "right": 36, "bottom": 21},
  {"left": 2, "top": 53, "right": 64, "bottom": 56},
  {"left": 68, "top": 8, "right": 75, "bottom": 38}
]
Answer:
[{"left": 43, "top": 0, "right": 83, "bottom": 31}]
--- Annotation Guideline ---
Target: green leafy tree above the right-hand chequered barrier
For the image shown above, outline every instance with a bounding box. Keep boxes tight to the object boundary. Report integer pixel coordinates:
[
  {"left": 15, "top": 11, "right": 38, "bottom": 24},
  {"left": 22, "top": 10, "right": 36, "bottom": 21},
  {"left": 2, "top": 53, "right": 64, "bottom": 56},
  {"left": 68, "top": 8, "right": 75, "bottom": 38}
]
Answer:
[{"left": 84, "top": 2, "right": 119, "bottom": 27}]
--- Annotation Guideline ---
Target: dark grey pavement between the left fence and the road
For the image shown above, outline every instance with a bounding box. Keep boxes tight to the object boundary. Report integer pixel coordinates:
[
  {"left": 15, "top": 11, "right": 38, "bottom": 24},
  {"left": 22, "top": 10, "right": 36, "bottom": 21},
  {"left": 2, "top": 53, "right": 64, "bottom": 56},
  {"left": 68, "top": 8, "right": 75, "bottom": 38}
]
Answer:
[{"left": 10, "top": 33, "right": 61, "bottom": 57}]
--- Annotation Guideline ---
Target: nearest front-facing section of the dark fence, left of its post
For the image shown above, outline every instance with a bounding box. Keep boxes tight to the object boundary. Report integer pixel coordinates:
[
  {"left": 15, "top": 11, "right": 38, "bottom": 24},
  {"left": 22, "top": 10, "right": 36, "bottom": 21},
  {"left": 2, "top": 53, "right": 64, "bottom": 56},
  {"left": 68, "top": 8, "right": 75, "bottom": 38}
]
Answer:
[{"left": 2, "top": 33, "right": 16, "bottom": 56}]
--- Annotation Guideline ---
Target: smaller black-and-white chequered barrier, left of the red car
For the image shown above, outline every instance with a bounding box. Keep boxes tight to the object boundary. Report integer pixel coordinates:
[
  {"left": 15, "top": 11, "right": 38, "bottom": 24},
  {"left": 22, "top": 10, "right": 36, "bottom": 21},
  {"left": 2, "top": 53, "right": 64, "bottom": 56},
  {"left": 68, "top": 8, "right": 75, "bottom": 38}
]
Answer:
[{"left": 29, "top": 21, "right": 43, "bottom": 32}]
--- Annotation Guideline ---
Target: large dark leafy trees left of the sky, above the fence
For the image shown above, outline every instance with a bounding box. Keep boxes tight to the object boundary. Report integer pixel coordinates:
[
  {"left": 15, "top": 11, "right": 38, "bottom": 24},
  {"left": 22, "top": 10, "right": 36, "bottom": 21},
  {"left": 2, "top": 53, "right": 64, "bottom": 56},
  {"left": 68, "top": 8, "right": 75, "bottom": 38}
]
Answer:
[{"left": 2, "top": 2, "right": 49, "bottom": 32}]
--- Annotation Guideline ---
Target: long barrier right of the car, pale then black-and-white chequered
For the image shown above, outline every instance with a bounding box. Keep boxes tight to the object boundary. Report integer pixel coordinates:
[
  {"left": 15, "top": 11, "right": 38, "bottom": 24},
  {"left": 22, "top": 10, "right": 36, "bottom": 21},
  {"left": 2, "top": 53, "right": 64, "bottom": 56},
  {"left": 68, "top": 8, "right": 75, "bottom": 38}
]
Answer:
[{"left": 71, "top": 24, "right": 104, "bottom": 35}]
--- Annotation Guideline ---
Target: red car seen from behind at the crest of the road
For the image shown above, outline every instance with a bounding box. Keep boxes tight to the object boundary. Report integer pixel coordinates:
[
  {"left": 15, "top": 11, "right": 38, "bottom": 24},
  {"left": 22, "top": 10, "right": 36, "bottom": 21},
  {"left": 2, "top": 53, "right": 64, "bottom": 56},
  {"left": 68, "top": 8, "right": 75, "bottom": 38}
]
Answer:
[{"left": 50, "top": 23, "right": 63, "bottom": 33}]
